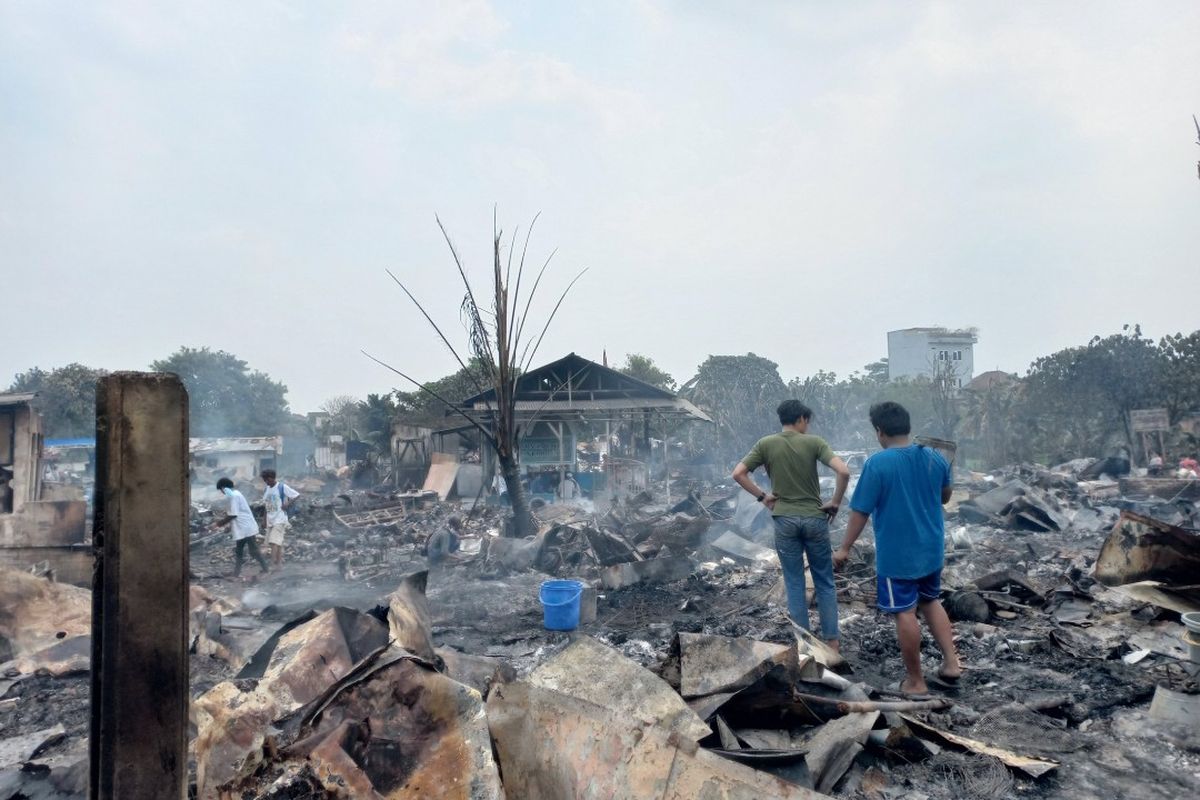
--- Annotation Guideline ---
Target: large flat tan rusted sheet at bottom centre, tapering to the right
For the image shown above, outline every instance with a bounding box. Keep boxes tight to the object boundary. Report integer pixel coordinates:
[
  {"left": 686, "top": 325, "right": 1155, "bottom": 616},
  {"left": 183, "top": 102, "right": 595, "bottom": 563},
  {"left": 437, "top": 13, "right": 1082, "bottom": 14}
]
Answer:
[{"left": 487, "top": 682, "right": 827, "bottom": 800}]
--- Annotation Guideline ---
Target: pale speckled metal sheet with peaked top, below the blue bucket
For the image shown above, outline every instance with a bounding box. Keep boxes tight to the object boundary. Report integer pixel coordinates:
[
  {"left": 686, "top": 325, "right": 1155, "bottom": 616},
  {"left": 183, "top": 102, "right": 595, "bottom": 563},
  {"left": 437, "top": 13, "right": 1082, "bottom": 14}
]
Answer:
[{"left": 527, "top": 636, "right": 712, "bottom": 741}]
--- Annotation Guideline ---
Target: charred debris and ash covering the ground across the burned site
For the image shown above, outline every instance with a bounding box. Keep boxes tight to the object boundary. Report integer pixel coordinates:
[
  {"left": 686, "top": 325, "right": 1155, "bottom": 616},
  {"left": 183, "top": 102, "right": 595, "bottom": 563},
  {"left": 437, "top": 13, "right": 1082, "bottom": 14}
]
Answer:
[{"left": 0, "top": 453, "right": 1200, "bottom": 800}]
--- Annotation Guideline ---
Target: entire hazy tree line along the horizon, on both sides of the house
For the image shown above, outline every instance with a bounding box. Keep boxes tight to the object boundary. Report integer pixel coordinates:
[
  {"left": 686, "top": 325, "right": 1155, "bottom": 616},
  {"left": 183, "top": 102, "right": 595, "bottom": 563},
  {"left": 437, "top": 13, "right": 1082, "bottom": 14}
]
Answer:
[{"left": 10, "top": 325, "right": 1200, "bottom": 468}]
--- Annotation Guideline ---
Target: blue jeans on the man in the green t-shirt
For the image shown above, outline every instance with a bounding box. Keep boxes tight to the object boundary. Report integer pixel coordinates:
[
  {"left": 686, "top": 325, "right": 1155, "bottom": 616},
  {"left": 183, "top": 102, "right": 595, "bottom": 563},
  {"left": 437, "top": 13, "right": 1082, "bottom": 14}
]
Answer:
[{"left": 775, "top": 517, "right": 838, "bottom": 640}]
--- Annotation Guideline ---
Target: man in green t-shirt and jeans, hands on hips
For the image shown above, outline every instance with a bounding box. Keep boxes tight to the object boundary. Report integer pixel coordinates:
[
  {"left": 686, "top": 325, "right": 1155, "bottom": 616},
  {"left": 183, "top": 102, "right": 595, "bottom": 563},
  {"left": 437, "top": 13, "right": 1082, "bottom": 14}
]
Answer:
[{"left": 733, "top": 399, "right": 850, "bottom": 650}]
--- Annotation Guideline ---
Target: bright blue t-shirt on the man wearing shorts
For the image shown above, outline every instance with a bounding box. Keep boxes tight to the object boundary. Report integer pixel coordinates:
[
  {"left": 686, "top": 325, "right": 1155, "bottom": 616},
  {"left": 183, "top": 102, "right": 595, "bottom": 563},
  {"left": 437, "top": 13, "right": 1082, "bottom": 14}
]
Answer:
[{"left": 850, "top": 445, "right": 950, "bottom": 581}]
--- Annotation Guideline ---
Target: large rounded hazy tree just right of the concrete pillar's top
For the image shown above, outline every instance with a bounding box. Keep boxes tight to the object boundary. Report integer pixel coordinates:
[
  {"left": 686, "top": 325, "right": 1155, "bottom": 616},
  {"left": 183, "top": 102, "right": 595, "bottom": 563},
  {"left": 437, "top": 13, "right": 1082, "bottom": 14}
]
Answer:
[{"left": 150, "top": 347, "right": 288, "bottom": 437}]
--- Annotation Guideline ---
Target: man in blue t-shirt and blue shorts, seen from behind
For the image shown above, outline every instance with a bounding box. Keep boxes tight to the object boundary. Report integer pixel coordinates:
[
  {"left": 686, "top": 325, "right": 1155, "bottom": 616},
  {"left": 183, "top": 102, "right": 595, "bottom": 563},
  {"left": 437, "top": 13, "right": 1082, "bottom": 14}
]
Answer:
[{"left": 833, "top": 403, "right": 962, "bottom": 697}]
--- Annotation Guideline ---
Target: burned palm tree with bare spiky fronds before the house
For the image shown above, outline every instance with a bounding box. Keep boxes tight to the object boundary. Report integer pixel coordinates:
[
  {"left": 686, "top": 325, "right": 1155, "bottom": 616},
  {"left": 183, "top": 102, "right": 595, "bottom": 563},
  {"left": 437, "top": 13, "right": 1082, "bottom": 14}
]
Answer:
[{"left": 365, "top": 217, "right": 587, "bottom": 536}]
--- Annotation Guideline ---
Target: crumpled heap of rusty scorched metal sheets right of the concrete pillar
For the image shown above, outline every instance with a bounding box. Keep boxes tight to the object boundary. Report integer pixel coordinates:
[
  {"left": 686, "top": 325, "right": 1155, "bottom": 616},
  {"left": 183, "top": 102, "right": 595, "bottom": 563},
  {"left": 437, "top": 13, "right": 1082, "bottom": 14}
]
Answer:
[{"left": 193, "top": 572, "right": 487, "bottom": 800}]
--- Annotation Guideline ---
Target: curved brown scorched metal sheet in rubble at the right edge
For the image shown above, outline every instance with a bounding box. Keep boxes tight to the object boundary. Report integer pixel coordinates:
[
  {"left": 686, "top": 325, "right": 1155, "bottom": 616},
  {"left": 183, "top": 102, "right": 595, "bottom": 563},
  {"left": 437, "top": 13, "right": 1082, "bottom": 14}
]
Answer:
[{"left": 1096, "top": 511, "right": 1200, "bottom": 588}]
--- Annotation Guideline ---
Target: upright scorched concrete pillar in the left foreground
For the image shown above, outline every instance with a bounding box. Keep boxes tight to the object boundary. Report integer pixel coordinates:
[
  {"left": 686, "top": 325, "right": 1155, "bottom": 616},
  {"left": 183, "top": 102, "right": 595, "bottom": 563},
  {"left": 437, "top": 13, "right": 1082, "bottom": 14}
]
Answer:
[{"left": 90, "top": 372, "right": 188, "bottom": 800}]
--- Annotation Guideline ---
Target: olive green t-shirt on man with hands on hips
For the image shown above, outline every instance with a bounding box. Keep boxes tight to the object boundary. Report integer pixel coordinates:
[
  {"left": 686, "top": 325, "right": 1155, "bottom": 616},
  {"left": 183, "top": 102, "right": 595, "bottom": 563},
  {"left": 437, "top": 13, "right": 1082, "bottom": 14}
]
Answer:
[{"left": 742, "top": 431, "right": 834, "bottom": 517}]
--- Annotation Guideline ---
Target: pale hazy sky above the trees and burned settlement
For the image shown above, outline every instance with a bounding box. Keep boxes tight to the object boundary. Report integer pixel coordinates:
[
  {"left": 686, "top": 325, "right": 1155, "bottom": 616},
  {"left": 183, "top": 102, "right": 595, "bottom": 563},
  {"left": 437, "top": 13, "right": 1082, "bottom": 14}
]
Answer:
[{"left": 0, "top": 0, "right": 1200, "bottom": 411}]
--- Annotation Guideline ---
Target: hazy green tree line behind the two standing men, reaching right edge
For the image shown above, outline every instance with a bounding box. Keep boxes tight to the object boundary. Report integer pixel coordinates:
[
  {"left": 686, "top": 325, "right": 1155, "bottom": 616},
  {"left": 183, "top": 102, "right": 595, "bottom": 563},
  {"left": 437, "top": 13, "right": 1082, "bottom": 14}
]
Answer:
[{"left": 682, "top": 325, "right": 1200, "bottom": 468}]
